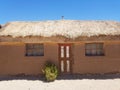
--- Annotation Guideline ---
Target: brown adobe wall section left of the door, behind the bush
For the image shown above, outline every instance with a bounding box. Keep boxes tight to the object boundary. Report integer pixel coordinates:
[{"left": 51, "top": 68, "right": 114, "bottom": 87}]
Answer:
[{"left": 0, "top": 43, "right": 58, "bottom": 75}]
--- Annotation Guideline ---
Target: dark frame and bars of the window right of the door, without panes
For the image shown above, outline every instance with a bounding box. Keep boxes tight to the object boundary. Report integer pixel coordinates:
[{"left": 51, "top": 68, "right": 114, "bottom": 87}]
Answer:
[{"left": 85, "top": 42, "right": 105, "bottom": 56}]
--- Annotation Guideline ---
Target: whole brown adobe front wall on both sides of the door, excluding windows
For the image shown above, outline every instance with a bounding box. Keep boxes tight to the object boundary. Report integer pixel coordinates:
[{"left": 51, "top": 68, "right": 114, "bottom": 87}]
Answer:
[{"left": 0, "top": 41, "right": 120, "bottom": 75}]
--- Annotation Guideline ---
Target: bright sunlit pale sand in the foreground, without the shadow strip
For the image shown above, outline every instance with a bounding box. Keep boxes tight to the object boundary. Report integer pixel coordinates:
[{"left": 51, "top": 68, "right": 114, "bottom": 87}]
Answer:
[{"left": 0, "top": 79, "right": 120, "bottom": 90}]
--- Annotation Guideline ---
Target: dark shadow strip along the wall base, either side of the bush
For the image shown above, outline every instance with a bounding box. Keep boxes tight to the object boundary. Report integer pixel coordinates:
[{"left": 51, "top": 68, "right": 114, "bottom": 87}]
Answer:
[{"left": 0, "top": 73, "right": 120, "bottom": 82}]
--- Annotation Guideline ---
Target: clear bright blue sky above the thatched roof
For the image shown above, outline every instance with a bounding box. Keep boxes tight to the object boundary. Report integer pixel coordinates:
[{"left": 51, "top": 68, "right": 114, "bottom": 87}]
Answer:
[{"left": 0, "top": 0, "right": 120, "bottom": 24}]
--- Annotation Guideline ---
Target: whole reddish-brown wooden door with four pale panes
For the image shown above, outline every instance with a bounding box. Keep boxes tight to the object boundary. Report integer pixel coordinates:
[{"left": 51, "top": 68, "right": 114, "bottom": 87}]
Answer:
[{"left": 59, "top": 44, "right": 72, "bottom": 73}]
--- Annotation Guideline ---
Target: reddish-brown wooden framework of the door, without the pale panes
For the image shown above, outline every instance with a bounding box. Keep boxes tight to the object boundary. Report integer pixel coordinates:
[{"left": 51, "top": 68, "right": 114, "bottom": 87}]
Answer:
[{"left": 58, "top": 43, "right": 73, "bottom": 74}]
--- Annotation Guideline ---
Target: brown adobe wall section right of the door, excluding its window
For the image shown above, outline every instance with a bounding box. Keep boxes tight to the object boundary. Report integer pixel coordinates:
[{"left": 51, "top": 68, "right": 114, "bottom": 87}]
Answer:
[{"left": 73, "top": 41, "right": 120, "bottom": 74}]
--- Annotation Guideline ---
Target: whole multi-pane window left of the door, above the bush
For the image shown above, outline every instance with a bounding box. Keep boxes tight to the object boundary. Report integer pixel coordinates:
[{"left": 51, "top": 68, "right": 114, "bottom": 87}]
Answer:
[{"left": 26, "top": 44, "right": 44, "bottom": 56}]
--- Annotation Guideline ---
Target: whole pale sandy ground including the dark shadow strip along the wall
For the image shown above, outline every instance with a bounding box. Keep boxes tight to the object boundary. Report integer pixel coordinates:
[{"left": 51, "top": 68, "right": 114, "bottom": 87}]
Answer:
[{"left": 0, "top": 74, "right": 120, "bottom": 90}]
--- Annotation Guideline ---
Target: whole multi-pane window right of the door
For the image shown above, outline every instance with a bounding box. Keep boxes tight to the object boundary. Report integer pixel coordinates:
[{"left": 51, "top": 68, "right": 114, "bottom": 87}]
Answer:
[{"left": 85, "top": 43, "right": 104, "bottom": 56}]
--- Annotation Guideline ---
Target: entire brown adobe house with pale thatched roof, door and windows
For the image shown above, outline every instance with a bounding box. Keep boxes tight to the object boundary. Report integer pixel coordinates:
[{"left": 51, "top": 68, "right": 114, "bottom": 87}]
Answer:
[{"left": 0, "top": 20, "right": 120, "bottom": 75}]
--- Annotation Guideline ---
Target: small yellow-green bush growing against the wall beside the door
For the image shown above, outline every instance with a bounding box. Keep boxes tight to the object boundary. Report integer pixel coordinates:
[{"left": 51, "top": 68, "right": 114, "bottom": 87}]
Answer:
[{"left": 43, "top": 63, "right": 58, "bottom": 82}]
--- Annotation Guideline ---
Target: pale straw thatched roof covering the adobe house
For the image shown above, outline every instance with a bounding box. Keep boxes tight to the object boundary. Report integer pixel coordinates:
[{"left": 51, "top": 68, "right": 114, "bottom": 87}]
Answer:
[{"left": 0, "top": 20, "right": 120, "bottom": 39}]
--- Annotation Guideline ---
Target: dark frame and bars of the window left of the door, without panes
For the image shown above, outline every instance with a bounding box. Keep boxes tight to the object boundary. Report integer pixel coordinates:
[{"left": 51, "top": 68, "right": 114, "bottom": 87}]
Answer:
[{"left": 25, "top": 43, "right": 44, "bottom": 57}]
